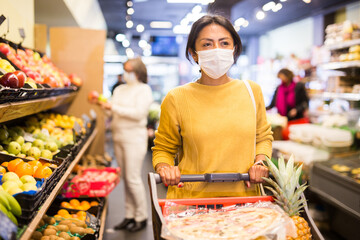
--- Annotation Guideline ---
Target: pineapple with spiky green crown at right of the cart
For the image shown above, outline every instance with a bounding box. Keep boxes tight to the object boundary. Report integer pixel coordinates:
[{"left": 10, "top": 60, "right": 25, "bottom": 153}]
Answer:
[{"left": 264, "top": 156, "right": 312, "bottom": 240}]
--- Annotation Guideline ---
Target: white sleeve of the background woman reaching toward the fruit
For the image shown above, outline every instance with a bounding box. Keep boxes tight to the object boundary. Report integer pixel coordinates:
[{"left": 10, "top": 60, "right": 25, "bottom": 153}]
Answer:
[{"left": 111, "top": 87, "right": 153, "bottom": 120}]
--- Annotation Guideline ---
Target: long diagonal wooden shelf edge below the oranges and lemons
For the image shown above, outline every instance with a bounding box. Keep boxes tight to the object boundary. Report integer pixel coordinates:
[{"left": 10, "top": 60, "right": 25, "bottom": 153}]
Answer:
[{"left": 20, "top": 128, "right": 97, "bottom": 240}]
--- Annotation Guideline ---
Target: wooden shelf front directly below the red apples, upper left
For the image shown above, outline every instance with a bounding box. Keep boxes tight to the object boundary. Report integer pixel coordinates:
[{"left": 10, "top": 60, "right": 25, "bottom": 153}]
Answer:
[{"left": 0, "top": 92, "right": 77, "bottom": 123}]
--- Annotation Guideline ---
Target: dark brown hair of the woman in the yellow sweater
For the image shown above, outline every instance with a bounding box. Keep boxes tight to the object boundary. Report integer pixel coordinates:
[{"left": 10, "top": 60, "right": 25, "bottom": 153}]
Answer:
[{"left": 185, "top": 15, "right": 242, "bottom": 62}]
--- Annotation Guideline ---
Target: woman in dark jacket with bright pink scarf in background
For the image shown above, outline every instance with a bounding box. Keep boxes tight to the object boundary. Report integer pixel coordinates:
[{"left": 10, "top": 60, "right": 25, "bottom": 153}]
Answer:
[{"left": 266, "top": 68, "right": 309, "bottom": 120}]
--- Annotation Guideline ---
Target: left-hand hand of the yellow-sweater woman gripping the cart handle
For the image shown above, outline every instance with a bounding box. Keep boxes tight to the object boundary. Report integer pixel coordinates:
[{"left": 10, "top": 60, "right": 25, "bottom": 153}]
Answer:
[{"left": 156, "top": 163, "right": 183, "bottom": 187}]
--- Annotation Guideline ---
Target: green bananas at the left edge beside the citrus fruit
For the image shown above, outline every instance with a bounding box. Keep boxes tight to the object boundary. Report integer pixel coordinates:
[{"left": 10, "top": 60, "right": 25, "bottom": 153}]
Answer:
[{"left": 0, "top": 188, "right": 22, "bottom": 225}]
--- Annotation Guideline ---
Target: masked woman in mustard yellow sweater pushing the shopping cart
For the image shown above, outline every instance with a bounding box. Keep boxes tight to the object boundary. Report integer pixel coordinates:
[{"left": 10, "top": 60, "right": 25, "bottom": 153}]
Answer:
[{"left": 152, "top": 16, "right": 273, "bottom": 198}]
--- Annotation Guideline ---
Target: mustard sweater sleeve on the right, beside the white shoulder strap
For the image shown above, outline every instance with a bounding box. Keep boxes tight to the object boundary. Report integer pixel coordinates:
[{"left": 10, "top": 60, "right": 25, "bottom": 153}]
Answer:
[{"left": 253, "top": 81, "right": 274, "bottom": 158}]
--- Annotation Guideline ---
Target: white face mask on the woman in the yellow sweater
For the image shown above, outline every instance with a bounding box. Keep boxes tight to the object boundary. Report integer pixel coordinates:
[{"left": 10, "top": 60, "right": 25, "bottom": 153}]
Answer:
[{"left": 197, "top": 48, "right": 234, "bottom": 79}]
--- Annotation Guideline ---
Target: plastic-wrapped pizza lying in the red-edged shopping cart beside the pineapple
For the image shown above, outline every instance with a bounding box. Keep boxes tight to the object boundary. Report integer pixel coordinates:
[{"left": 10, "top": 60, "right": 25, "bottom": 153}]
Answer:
[{"left": 161, "top": 201, "right": 297, "bottom": 240}]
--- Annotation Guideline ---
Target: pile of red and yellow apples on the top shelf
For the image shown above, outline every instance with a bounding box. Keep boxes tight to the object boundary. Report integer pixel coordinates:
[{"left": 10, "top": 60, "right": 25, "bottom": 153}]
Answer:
[{"left": 0, "top": 42, "right": 82, "bottom": 88}]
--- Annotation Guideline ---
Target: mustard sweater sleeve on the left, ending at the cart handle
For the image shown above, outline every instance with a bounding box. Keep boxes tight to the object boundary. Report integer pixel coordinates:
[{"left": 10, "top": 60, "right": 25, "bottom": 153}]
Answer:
[{"left": 152, "top": 91, "right": 181, "bottom": 169}]
